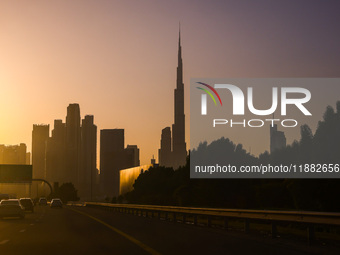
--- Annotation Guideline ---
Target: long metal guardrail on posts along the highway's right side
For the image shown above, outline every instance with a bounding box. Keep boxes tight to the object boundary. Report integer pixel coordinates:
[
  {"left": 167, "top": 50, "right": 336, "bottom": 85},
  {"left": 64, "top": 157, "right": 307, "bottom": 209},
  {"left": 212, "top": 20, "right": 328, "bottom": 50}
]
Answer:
[{"left": 85, "top": 202, "right": 340, "bottom": 243}]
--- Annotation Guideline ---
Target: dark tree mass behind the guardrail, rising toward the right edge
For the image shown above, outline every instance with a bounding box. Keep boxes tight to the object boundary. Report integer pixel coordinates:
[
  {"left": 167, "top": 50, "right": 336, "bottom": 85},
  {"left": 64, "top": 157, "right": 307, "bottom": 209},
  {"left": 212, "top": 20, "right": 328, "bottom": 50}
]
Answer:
[{"left": 125, "top": 101, "right": 340, "bottom": 211}]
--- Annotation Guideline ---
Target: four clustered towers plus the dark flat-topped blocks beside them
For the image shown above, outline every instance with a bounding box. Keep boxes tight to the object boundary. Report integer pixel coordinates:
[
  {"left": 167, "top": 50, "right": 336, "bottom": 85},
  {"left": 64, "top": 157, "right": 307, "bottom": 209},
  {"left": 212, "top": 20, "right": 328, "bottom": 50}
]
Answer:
[{"left": 32, "top": 104, "right": 139, "bottom": 200}]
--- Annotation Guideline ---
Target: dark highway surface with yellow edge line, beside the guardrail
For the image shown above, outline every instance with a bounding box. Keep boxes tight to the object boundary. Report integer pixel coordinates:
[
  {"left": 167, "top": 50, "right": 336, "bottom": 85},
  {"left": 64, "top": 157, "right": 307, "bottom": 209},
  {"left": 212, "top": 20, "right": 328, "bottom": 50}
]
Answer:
[{"left": 0, "top": 206, "right": 339, "bottom": 255}]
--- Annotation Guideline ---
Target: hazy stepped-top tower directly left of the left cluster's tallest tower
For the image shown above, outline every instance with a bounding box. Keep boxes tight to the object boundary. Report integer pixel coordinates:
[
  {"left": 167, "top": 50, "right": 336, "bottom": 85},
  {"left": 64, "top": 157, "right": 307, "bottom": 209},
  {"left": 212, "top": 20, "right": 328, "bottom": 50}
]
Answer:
[{"left": 46, "top": 120, "right": 69, "bottom": 184}]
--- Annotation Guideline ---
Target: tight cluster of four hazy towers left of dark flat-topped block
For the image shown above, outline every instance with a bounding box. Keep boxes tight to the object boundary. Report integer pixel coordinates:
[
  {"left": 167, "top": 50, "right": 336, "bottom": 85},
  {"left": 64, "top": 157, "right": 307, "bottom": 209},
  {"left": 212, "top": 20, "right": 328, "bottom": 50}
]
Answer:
[{"left": 32, "top": 104, "right": 98, "bottom": 198}]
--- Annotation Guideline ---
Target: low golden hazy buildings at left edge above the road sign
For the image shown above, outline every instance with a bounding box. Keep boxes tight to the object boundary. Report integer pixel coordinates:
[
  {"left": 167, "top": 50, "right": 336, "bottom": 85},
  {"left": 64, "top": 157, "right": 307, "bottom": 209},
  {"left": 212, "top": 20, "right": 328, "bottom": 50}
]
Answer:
[{"left": 0, "top": 143, "right": 31, "bottom": 165}]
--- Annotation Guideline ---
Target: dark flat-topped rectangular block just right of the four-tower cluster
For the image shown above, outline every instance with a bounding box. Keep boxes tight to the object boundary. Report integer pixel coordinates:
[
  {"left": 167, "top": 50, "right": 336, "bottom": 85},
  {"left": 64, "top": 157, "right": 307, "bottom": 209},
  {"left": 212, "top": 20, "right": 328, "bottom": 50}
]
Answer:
[{"left": 100, "top": 129, "right": 125, "bottom": 197}]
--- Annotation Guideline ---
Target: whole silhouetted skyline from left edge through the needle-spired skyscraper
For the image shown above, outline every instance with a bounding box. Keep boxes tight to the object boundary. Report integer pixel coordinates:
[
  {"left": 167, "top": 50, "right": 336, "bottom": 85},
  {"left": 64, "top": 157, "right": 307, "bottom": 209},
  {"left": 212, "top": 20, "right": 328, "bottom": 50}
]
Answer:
[{"left": 0, "top": 30, "right": 187, "bottom": 201}]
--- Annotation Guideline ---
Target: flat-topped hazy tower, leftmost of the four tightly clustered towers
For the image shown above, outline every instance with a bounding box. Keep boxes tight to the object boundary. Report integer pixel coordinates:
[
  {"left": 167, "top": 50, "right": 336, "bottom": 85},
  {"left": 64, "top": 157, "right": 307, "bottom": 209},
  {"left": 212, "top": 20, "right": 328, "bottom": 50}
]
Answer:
[{"left": 31, "top": 125, "right": 50, "bottom": 179}]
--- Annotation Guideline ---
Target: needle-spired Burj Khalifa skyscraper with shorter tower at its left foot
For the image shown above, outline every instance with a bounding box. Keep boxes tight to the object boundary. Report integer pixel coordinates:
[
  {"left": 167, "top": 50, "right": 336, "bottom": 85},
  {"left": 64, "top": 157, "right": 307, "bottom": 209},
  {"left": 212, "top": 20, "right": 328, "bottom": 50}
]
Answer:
[{"left": 160, "top": 27, "right": 187, "bottom": 169}]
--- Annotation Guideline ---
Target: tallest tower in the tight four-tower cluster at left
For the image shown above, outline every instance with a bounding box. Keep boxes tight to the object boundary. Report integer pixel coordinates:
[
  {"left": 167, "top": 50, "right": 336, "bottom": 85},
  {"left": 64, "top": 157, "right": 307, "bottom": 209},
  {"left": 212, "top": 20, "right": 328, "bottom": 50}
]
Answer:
[{"left": 66, "top": 104, "right": 81, "bottom": 187}]
